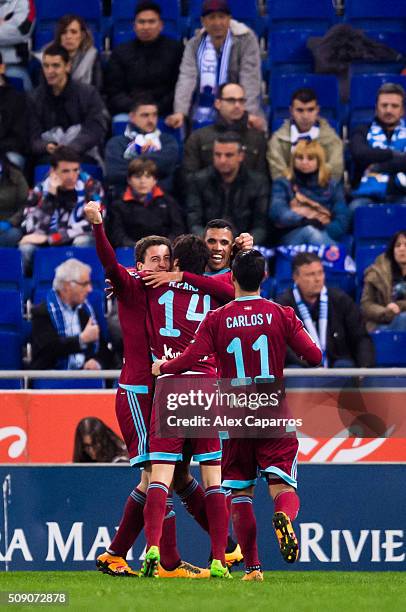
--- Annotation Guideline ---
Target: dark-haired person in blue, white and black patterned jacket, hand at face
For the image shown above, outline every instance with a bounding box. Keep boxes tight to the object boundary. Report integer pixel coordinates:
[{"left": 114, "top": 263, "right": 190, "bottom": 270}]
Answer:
[{"left": 19, "top": 147, "right": 103, "bottom": 272}]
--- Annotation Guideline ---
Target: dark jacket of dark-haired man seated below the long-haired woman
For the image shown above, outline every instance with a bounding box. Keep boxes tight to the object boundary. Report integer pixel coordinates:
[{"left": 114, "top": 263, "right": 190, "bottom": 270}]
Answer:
[{"left": 30, "top": 79, "right": 108, "bottom": 155}]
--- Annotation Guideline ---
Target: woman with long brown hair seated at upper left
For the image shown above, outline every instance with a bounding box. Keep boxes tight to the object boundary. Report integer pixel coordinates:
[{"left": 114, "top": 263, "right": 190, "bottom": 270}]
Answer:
[{"left": 50, "top": 15, "right": 103, "bottom": 90}]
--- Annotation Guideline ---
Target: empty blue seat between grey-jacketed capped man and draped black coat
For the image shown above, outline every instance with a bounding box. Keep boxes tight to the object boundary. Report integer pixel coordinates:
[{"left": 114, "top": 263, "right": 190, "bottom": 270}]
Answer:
[{"left": 268, "top": 30, "right": 324, "bottom": 76}]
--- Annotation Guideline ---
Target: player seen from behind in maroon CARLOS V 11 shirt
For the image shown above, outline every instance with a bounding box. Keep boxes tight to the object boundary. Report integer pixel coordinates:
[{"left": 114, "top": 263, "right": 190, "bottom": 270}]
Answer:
[{"left": 152, "top": 250, "right": 322, "bottom": 581}]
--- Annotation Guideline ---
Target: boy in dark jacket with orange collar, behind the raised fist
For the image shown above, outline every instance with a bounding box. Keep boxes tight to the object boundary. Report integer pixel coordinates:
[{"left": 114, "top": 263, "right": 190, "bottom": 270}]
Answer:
[{"left": 109, "top": 158, "right": 185, "bottom": 247}]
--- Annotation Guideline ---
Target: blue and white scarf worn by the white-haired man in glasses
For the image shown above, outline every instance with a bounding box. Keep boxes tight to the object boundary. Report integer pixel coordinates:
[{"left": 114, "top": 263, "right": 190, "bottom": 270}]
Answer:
[{"left": 47, "top": 289, "right": 99, "bottom": 370}]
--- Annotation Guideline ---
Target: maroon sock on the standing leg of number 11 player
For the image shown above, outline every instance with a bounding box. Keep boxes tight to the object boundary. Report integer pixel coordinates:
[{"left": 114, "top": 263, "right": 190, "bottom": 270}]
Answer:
[{"left": 231, "top": 495, "right": 260, "bottom": 568}]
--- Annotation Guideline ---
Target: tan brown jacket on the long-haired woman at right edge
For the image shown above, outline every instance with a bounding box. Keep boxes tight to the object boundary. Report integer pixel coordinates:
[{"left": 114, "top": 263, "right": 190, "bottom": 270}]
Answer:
[{"left": 361, "top": 253, "right": 406, "bottom": 331}]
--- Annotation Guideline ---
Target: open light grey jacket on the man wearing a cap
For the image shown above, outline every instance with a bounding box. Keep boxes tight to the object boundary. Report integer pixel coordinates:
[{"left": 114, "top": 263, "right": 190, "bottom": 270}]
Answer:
[{"left": 174, "top": 19, "right": 261, "bottom": 116}]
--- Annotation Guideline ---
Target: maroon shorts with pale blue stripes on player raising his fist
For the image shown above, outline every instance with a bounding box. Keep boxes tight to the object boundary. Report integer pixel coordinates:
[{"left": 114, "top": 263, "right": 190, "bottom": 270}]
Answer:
[{"left": 116, "top": 377, "right": 153, "bottom": 466}]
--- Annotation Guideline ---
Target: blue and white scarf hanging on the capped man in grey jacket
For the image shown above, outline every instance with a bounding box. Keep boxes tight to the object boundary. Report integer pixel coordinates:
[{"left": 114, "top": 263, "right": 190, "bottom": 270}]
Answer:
[{"left": 193, "top": 29, "right": 233, "bottom": 122}]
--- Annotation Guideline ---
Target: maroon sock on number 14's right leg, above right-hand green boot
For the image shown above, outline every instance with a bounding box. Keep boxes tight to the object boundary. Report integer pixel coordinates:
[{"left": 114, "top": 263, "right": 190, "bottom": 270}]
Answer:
[{"left": 205, "top": 486, "right": 228, "bottom": 565}]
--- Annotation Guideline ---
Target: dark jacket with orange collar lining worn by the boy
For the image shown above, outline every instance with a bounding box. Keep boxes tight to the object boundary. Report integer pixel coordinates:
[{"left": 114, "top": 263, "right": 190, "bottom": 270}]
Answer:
[{"left": 109, "top": 187, "right": 185, "bottom": 247}]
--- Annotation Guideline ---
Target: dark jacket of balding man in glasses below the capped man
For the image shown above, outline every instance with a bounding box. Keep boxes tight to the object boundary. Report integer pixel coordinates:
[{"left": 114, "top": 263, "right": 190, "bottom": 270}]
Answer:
[{"left": 182, "top": 114, "right": 268, "bottom": 174}]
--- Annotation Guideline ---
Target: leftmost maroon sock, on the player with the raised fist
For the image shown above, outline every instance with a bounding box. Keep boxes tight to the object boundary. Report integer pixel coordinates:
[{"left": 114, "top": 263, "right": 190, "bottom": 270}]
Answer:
[{"left": 108, "top": 488, "right": 146, "bottom": 559}]
